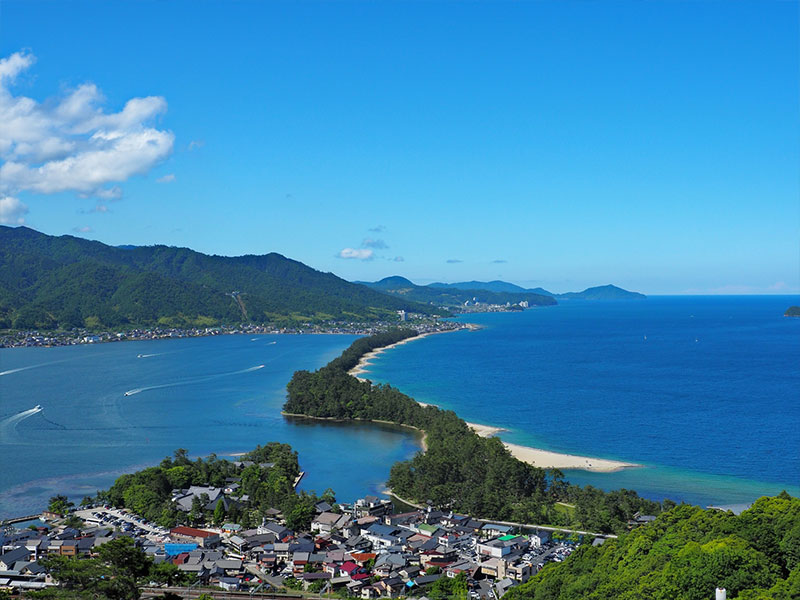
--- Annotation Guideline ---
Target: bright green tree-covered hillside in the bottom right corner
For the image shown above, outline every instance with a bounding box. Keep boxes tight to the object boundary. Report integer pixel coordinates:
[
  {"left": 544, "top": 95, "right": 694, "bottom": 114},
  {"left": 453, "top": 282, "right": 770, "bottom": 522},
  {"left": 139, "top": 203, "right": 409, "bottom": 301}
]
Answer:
[{"left": 504, "top": 492, "right": 800, "bottom": 600}]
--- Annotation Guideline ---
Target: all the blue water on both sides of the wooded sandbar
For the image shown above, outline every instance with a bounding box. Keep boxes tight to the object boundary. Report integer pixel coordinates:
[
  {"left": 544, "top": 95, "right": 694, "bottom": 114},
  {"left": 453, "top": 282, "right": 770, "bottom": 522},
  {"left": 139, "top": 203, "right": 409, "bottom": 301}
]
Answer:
[{"left": 0, "top": 296, "right": 800, "bottom": 518}]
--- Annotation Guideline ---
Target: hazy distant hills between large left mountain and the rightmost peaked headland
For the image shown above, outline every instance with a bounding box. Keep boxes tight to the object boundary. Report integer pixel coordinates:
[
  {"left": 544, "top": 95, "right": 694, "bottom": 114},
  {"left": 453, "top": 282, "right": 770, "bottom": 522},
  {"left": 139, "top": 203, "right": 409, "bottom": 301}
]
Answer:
[{"left": 359, "top": 275, "right": 556, "bottom": 307}]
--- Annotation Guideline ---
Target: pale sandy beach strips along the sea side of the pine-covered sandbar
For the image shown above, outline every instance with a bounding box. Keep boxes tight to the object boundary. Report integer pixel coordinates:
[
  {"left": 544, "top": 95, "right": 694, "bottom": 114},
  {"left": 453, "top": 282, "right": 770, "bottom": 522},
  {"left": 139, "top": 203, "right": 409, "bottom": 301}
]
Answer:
[{"left": 349, "top": 338, "right": 642, "bottom": 473}]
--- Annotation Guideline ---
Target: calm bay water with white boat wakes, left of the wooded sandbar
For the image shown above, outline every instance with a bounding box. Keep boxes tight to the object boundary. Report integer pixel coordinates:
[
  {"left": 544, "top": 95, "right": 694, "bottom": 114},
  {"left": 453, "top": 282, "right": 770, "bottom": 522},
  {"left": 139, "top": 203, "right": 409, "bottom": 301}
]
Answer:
[{"left": 0, "top": 335, "right": 418, "bottom": 518}]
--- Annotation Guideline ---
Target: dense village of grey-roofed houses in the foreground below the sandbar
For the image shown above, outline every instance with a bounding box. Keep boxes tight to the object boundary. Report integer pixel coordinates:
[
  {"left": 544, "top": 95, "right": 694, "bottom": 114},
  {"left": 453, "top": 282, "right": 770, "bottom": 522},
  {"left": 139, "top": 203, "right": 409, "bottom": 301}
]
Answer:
[{"left": 0, "top": 490, "right": 628, "bottom": 600}]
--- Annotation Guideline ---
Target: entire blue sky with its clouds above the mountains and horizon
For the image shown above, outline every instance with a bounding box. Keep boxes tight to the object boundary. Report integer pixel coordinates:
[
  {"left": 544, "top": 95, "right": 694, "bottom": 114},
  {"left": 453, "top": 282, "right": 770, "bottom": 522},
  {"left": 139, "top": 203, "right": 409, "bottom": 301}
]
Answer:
[{"left": 0, "top": 0, "right": 800, "bottom": 293}]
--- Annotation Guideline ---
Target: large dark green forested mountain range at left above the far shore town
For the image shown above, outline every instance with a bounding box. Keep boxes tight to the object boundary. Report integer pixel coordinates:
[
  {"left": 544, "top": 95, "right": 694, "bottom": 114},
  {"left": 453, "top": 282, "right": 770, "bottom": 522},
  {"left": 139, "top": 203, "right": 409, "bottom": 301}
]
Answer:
[{"left": 0, "top": 226, "right": 441, "bottom": 329}]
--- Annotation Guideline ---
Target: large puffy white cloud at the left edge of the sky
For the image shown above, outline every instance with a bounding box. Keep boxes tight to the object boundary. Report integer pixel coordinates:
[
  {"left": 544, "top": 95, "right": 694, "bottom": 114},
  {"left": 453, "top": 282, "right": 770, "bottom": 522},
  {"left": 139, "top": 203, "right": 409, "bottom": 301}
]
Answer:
[{"left": 0, "top": 52, "right": 175, "bottom": 199}]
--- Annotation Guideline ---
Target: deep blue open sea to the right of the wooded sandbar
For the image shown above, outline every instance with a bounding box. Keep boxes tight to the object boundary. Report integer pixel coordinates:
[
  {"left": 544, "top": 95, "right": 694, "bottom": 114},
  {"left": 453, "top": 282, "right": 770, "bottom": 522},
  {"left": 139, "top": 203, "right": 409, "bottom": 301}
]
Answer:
[{"left": 365, "top": 296, "right": 800, "bottom": 505}]
